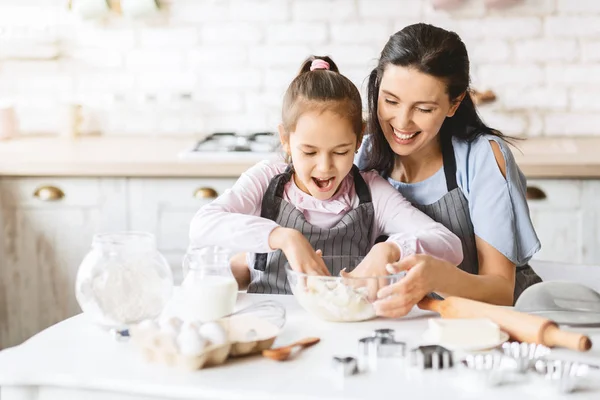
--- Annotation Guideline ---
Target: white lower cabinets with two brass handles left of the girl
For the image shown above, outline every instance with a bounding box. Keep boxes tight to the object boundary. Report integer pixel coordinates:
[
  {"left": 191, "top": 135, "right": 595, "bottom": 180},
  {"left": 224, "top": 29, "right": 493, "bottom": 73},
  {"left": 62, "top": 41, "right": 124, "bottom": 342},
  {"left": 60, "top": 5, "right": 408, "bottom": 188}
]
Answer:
[{"left": 0, "top": 178, "right": 235, "bottom": 349}]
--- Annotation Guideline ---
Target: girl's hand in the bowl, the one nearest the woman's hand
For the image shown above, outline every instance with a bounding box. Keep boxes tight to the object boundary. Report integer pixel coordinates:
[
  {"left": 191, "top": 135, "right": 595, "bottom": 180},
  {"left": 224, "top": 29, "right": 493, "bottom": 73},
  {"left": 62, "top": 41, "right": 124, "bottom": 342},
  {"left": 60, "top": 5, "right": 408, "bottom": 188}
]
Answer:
[{"left": 340, "top": 242, "right": 400, "bottom": 300}]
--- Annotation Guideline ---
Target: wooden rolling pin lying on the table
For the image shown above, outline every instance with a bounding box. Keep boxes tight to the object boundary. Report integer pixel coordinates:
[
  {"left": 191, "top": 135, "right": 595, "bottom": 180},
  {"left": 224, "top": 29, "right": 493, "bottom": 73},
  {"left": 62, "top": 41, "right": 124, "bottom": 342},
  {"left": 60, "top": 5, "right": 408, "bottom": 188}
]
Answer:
[{"left": 419, "top": 297, "right": 592, "bottom": 351}]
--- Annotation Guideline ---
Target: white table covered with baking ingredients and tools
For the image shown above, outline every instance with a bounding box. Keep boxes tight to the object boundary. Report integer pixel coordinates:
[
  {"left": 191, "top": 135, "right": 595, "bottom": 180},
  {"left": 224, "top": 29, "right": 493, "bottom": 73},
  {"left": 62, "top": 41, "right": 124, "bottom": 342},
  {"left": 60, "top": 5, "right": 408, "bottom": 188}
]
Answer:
[{"left": 0, "top": 260, "right": 600, "bottom": 400}]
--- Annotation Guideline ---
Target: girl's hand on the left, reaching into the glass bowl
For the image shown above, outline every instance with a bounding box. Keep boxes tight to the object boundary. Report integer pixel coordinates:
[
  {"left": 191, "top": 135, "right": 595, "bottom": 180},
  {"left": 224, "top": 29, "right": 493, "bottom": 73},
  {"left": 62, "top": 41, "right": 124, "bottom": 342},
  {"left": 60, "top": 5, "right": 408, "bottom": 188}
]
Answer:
[{"left": 269, "top": 227, "right": 331, "bottom": 275}]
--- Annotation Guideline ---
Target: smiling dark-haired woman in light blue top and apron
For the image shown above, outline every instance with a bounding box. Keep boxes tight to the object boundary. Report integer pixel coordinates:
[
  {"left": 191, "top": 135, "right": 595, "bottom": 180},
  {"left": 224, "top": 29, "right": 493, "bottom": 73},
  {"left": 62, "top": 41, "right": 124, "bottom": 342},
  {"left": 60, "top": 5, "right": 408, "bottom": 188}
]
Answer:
[{"left": 357, "top": 24, "right": 540, "bottom": 317}]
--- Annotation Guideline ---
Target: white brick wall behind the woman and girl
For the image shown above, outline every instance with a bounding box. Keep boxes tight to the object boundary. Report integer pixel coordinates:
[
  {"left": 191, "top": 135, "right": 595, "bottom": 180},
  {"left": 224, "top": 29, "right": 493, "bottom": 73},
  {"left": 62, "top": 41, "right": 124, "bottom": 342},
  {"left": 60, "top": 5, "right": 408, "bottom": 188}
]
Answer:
[{"left": 0, "top": 0, "right": 600, "bottom": 136}]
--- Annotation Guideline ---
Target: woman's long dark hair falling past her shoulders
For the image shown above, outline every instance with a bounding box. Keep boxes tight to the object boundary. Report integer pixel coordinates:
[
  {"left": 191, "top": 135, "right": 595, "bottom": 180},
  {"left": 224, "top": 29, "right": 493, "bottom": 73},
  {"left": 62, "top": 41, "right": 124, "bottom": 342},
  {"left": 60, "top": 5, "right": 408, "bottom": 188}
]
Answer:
[{"left": 364, "top": 23, "right": 505, "bottom": 172}]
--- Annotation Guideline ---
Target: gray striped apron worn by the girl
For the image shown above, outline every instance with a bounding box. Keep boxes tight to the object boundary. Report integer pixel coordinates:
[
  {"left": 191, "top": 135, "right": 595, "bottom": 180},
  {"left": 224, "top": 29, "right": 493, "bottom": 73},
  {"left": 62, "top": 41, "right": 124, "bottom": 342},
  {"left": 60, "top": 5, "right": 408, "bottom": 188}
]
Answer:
[{"left": 248, "top": 166, "right": 374, "bottom": 294}]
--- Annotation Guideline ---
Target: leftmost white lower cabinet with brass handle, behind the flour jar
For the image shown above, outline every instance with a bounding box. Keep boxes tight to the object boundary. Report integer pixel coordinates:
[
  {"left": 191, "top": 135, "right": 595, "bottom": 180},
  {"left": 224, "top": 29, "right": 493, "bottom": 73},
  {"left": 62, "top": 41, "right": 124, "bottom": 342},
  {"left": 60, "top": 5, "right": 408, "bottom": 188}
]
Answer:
[{"left": 0, "top": 178, "right": 126, "bottom": 349}]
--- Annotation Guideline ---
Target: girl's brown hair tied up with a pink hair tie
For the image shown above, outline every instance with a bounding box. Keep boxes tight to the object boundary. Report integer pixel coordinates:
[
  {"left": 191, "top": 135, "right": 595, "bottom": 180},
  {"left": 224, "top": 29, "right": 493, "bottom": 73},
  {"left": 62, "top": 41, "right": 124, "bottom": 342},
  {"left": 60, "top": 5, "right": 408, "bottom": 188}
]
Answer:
[{"left": 281, "top": 56, "right": 363, "bottom": 138}]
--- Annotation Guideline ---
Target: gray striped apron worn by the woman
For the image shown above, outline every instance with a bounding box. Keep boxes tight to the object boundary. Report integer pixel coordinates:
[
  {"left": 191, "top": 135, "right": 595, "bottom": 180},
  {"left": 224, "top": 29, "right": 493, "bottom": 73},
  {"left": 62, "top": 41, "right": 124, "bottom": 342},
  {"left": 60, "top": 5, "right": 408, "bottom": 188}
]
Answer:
[{"left": 377, "top": 138, "right": 542, "bottom": 301}]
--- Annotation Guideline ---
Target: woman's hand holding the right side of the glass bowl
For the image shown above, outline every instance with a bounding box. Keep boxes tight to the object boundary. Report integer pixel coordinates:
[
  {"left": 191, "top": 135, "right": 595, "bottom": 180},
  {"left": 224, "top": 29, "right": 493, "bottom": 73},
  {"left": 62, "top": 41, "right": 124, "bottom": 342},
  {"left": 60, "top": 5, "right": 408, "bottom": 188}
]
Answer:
[{"left": 375, "top": 254, "right": 456, "bottom": 318}]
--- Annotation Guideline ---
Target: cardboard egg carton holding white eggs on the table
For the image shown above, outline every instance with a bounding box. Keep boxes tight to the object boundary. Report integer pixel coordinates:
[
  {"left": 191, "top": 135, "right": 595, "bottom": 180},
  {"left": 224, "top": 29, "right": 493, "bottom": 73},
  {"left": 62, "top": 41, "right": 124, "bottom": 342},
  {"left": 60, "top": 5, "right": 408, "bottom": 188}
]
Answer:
[{"left": 130, "top": 315, "right": 279, "bottom": 370}]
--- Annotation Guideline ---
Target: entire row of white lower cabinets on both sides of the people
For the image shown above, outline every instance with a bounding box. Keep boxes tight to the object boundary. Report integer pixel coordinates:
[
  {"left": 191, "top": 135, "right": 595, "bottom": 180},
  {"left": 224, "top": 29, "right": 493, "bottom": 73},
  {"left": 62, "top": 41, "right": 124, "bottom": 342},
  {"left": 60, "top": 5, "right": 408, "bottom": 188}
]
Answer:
[{"left": 0, "top": 173, "right": 600, "bottom": 348}]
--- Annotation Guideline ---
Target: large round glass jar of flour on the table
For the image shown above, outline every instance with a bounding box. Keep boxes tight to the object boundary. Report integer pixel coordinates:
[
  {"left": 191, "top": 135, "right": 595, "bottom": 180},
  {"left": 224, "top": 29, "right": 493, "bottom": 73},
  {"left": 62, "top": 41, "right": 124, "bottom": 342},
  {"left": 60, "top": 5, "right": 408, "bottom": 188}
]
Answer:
[{"left": 75, "top": 232, "right": 173, "bottom": 329}]
